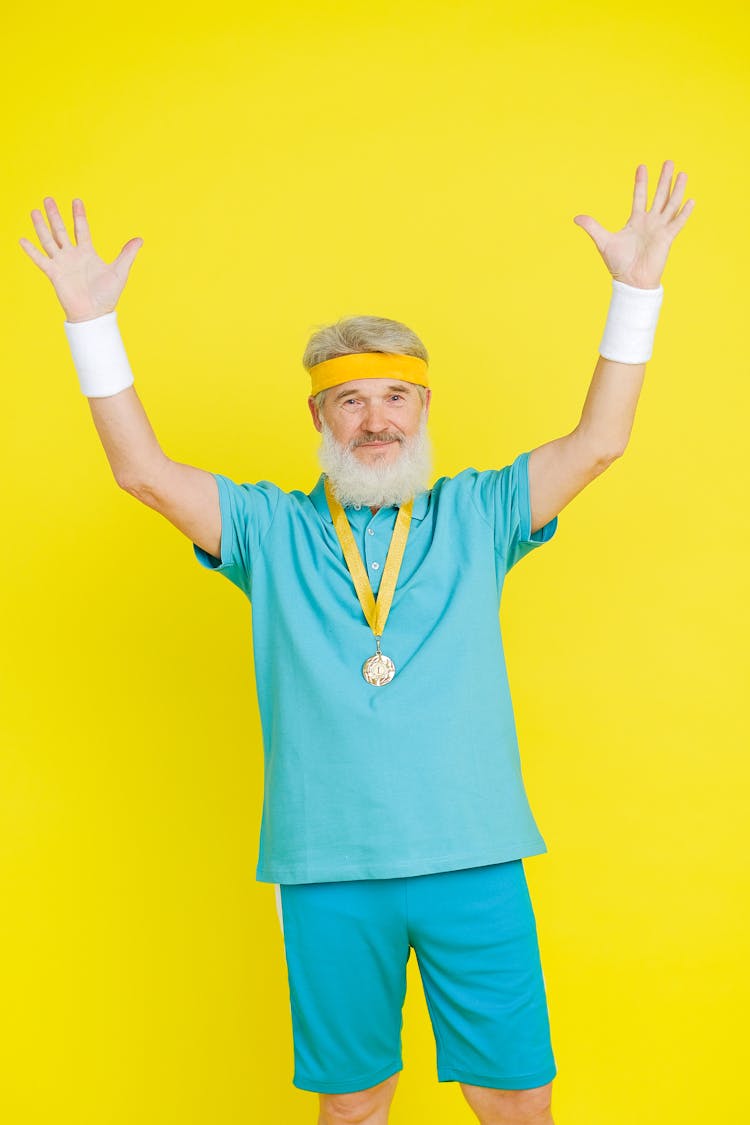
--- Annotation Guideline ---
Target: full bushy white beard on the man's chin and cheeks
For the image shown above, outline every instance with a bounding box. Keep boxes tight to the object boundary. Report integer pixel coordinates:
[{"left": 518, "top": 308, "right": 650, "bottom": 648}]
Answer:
[{"left": 318, "top": 415, "right": 432, "bottom": 507}]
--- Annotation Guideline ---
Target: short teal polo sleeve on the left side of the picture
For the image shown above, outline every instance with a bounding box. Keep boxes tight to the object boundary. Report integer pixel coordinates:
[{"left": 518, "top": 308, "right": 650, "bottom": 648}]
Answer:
[{"left": 192, "top": 473, "right": 281, "bottom": 597}]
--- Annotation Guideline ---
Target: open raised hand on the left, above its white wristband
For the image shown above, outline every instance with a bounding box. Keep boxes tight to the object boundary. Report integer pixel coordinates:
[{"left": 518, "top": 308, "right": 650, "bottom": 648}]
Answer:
[{"left": 19, "top": 196, "right": 143, "bottom": 324}]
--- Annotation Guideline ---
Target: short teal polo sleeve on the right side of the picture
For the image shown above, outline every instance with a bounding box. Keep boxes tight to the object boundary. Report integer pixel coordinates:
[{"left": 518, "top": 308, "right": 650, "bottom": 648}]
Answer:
[{"left": 473, "top": 450, "right": 558, "bottom": 573}]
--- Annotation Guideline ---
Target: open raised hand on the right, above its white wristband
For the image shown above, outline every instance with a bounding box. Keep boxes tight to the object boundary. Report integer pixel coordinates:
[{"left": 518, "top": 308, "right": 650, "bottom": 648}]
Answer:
[{"left": 573, "top": 160, "right": 695, "bottom": 289}]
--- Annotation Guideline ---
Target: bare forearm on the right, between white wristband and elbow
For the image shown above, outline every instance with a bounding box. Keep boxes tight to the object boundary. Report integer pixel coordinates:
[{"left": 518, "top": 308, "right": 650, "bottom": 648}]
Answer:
[{"left": 576, "top": 356, "right": 645, "bottom": 457}]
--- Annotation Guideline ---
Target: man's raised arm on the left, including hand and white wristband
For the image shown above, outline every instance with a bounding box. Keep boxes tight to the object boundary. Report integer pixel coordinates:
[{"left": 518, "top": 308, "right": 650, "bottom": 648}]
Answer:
[{"left": 19, "top": 198, "right": 222, "bottom": 558}]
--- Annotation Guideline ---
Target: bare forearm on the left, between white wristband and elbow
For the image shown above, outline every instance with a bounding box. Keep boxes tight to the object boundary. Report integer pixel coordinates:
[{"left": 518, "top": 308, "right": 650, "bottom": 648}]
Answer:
[{"left": 88, "top": 387, "right": 169, "bottom": 492}]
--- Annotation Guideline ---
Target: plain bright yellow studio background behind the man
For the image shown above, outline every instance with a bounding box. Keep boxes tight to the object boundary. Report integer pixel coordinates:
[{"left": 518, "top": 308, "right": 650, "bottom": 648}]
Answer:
[{"left": 0, "top": 0, "right": 750, "bottom": 1125}]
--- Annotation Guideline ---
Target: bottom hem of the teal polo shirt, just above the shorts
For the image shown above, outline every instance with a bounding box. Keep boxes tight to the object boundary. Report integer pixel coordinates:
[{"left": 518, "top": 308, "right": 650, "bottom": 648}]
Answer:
[{"left": 255, "top": 838, "right": 548, "bottom": 883}]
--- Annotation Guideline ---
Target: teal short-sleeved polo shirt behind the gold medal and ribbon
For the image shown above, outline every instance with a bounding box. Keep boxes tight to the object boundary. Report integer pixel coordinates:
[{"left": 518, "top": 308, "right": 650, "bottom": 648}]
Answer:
[{"left": 193, "top": 452, "right": 558, "bottom": 883}]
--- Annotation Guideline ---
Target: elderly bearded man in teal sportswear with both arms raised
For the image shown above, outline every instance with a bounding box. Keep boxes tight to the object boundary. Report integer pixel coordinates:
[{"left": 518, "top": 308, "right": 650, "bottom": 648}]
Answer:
[{"left": 20, "top": 161, "right": 693, "bottom": 1125}]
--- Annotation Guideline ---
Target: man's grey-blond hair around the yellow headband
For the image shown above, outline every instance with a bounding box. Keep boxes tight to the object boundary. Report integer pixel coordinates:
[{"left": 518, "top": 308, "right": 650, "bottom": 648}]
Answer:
[{"left": 302, "top": 316, "right": 430, "bottom": 410}]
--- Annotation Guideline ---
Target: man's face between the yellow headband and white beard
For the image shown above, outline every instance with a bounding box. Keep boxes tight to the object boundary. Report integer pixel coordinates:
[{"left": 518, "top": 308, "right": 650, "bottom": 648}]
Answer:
[{"left": 308, "top": 379, "right": 430, "bottom": 465}]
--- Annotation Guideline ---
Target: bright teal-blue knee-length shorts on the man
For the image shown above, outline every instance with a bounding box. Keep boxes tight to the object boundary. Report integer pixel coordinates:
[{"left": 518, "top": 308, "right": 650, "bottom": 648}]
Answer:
[{"left": 278, "top": 860, "right": 557, "bottom": 1094}]
